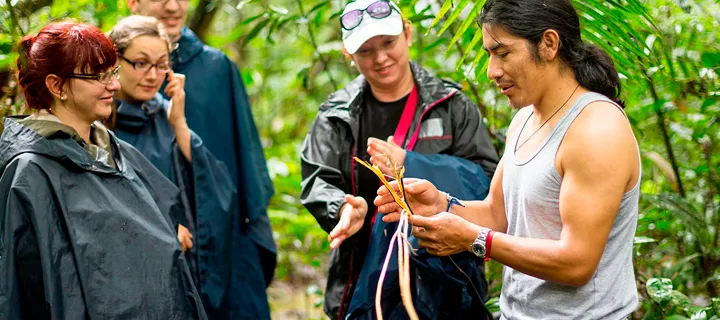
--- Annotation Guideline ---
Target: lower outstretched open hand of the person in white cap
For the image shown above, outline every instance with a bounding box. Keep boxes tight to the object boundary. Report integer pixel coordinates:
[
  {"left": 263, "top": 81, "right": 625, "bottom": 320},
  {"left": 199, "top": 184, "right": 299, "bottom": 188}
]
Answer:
[{"left": 328, "top": 194, "right": 368, "bottom": 249}]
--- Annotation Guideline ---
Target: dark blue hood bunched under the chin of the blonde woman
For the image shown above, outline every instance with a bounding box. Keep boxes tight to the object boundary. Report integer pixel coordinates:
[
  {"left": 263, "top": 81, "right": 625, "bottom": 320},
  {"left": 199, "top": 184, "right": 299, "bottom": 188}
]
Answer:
[{"left": 115, "top": 92, "right": 170, "bottom": 132}]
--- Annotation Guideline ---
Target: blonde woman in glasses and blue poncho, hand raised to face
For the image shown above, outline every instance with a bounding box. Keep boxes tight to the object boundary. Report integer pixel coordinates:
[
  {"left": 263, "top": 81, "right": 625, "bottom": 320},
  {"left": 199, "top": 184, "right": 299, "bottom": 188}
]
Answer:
[{"left": 106, "top": 16, "right": 237, "bottom": 318}]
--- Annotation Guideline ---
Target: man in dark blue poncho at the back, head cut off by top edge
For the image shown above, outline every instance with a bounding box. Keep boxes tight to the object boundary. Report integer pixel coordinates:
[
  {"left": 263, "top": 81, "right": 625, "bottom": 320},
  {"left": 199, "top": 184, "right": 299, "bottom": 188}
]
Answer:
[{"left": 127, "top": 0, "right": 277, "bottom": 319}]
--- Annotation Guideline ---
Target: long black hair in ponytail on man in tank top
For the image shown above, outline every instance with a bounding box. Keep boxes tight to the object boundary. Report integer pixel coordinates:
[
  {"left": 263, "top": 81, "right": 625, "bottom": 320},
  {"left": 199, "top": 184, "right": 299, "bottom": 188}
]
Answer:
[{"left": 478, "top": 0, "right": 625, "bottom": 108}]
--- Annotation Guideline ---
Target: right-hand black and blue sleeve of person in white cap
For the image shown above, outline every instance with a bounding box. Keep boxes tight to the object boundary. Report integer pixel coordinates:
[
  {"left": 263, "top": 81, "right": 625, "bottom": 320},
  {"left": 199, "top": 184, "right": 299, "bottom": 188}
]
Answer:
[{"left": 405, "top": 93, "right": 498, "bottom": 200}]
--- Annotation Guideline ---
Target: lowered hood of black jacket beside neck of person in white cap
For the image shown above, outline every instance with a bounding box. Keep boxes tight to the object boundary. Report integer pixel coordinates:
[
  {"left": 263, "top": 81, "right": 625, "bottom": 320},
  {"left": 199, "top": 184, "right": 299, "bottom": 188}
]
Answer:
[{"left": 319, "top": 61, "right": 460, "bottom": 118}]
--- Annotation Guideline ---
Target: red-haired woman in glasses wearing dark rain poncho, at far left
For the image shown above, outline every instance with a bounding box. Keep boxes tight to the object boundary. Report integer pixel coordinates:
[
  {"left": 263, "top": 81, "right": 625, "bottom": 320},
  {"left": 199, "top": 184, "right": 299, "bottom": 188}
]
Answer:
[{"left": 0, "top": 22, "right": 207, "bottom": 319}]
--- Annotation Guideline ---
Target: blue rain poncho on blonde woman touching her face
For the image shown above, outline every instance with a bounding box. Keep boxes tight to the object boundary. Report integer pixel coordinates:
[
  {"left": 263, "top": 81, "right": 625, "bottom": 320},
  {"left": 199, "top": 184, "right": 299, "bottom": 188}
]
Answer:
[{"left": 114, "top": 93, "right": 237, "bottom": 311}]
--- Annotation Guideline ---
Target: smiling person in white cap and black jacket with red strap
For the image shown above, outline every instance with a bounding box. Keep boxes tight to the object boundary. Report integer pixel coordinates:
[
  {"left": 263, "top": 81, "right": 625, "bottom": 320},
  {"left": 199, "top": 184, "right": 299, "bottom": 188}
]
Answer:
[{"left": 301, "top": 0, "right": 498, "bottom": 319}]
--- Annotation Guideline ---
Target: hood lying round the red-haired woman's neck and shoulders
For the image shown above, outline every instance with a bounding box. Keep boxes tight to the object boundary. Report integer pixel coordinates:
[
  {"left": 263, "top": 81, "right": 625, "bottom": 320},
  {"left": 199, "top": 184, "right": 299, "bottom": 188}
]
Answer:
[{"left": 0, "top": 116, "right": 116, "bottom": 173}]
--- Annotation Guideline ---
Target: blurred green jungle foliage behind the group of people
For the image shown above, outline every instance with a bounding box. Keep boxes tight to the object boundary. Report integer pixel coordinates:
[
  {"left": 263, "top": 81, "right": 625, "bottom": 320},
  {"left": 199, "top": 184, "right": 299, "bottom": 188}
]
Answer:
[{"left": 0, "top": 0, "right": 720, "bottom": 319}]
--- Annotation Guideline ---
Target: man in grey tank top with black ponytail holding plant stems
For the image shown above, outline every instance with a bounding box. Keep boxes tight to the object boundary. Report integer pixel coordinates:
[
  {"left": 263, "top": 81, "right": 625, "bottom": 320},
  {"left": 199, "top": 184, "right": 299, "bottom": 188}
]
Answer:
[{"left": 375, "top": 0, "right": 641, "bottom": 319}]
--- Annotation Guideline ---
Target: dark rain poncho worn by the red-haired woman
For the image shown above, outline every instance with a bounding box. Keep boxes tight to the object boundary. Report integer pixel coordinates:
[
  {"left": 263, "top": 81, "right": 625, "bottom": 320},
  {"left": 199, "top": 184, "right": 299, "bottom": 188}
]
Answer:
[{"left": 0, "top": 118, "right": 206, "bottom": 319}]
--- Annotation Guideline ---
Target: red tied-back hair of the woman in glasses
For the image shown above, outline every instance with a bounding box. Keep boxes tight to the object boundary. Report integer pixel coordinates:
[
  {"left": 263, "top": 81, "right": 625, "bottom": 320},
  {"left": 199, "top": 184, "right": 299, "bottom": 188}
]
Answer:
[{"left": 17, "top": 21, "right": 117, "bottom": 109}]
